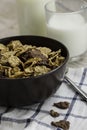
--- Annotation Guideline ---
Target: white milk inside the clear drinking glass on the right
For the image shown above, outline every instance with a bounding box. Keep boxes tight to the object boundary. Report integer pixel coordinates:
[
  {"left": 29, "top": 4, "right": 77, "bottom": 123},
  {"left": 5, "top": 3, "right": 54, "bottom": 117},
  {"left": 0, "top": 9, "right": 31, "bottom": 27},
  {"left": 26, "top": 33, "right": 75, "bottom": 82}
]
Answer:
[{"left": 47, "top": 13, "right": 87, "bottom": 57}]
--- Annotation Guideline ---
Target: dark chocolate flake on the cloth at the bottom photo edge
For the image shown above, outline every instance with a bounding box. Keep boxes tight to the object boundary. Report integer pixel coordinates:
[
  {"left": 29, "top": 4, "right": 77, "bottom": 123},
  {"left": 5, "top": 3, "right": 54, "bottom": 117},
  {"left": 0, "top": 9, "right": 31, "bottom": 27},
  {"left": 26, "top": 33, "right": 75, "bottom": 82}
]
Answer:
[{"left": 51, "top": 120, "right": 70, "bottom": 130}]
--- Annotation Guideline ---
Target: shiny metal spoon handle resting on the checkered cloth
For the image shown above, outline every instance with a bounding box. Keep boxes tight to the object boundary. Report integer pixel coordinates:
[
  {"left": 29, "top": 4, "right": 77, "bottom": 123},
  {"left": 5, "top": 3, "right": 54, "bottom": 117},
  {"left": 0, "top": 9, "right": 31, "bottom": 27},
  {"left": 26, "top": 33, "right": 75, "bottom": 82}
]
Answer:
[{"left": 65, "top": 76, "right": 87, "bottom": 102}]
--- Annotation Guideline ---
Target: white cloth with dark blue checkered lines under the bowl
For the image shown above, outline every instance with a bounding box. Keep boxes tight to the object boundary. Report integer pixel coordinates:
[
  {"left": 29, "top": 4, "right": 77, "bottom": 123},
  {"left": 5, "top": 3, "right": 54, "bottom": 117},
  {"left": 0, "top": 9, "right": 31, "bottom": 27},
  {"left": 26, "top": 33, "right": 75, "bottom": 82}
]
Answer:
[{"left": 0, "top": 68, "right": 87, "bottom": 130}]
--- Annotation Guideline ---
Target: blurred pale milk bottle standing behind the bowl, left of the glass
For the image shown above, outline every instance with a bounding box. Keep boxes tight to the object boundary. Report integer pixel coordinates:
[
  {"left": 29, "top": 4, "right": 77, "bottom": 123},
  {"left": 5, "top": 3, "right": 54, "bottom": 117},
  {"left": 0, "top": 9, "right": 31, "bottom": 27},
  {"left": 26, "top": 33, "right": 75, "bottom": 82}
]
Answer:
[{"left": 17, "top": 0, "right": 49, "bottom": 36}]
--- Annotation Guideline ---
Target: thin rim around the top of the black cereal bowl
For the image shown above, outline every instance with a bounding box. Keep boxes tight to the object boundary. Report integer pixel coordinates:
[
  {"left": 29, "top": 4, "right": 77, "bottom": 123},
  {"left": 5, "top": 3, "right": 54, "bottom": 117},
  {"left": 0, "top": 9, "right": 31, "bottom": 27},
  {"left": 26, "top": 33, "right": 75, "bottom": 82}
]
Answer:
[{"left": 0, "top": 35, "right": 69, "bottom": 80}]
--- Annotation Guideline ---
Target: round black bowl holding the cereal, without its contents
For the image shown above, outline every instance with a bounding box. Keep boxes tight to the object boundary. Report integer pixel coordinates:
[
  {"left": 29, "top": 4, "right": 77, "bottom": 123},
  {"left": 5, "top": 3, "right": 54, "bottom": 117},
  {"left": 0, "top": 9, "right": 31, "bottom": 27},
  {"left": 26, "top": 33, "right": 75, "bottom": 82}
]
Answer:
[{"left": 0, "top": 36, "right": 69, "bottom": 107}]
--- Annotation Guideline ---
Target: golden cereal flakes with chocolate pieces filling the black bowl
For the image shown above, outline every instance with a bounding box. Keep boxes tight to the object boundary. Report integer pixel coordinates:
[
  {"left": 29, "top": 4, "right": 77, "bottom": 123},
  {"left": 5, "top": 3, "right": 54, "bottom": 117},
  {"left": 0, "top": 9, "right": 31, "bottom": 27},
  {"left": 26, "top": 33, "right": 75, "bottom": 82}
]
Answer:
[{"left": 0, "top": 40, "right": 65, "bottom": 78}]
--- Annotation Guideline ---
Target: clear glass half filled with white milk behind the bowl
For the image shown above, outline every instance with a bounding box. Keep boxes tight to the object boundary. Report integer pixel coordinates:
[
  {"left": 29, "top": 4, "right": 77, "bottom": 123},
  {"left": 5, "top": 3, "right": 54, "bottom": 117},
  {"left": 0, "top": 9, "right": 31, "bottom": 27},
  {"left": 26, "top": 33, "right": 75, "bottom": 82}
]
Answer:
[{"left": 45, "top": 0, "right": 87, "bottom": 61}]
